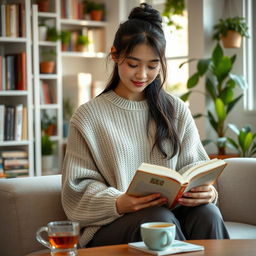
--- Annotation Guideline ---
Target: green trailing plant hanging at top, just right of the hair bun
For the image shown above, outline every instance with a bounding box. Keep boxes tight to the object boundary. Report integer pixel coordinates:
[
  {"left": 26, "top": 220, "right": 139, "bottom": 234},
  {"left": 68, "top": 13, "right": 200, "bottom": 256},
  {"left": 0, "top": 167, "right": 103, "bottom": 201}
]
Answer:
[{"left": 162, "top": 0, "right": 185, "bottom": 29}]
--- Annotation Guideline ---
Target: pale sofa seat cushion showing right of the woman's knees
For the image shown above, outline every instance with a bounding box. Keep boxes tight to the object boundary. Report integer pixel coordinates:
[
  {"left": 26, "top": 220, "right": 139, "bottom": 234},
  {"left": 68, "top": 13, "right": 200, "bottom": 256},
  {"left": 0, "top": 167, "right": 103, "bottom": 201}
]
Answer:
[{"left": 225, "top": 221, "right": 256, "bottom": 239}]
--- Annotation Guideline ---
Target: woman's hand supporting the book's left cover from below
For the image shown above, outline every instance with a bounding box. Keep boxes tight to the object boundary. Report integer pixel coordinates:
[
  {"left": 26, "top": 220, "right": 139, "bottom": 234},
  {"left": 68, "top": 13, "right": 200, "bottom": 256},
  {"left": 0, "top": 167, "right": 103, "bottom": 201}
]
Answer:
[{"left": 116, "top": 194, "right": 167, "bottom": 214}]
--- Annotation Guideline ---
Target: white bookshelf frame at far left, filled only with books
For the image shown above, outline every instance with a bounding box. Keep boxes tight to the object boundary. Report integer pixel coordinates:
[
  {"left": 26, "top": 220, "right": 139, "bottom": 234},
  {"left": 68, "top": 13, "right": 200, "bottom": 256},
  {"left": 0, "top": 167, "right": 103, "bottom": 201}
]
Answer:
[{"left": 0, "top": 0, "right": 35, "bottom": 176}]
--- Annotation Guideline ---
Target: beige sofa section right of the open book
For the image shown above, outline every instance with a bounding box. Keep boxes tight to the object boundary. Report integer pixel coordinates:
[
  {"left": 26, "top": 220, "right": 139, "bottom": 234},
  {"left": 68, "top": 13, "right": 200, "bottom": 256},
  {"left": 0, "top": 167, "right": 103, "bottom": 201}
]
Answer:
[{"left": 217, "top": 157, "right": 256, "bottom": 225}]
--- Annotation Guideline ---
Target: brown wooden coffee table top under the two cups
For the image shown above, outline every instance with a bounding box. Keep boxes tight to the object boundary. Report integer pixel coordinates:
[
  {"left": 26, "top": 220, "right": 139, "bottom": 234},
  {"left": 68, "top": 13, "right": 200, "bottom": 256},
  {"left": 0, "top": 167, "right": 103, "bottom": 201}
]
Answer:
[{"left": 33, "top": 239, "right": 256, "bottom": 256}]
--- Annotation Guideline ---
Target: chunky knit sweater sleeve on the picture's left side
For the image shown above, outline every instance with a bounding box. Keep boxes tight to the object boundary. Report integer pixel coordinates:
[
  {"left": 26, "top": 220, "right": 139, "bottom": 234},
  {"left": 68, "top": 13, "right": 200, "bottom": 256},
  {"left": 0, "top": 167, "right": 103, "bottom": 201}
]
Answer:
[{"left": 62, "top": 118, "right": 122, "bottom": 227}]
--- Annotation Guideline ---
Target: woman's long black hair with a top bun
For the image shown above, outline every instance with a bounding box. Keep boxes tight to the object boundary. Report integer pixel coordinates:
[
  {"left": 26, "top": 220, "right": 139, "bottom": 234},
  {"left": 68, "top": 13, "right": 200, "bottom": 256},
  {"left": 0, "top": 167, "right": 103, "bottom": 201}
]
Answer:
[{"left": 103, "top": 3, "right": 180, "bottom": 158}]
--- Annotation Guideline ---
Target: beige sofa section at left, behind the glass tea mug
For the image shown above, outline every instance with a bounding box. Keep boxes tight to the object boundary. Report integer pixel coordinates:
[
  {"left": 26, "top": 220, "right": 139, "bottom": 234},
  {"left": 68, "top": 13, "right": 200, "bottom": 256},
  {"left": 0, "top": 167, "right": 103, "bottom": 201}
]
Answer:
[{"left": 0, "top": 175, "right": 67, "bottom": 256}]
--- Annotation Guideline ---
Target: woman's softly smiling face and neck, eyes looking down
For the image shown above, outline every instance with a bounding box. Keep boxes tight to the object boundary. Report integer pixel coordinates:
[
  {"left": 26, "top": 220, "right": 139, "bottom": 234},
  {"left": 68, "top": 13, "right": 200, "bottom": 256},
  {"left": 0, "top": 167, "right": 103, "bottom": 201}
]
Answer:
[{"left": 115, "top": 44, "right": 161, "bottom": 101}]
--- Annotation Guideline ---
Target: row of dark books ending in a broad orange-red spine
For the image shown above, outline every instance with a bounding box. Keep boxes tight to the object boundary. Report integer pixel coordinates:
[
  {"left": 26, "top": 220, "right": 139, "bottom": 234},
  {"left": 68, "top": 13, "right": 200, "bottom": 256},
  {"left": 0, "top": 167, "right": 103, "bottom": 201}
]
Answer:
[{"left": 0, "top": 52, "right": 27, "bottom": 91}]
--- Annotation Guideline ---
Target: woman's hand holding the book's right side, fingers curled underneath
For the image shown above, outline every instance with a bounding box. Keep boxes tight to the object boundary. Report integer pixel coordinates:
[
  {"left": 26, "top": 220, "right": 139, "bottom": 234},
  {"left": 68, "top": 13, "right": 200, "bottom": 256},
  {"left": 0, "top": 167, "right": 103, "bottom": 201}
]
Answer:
[{"left": 179, "top": 185, "right": 215, "bottom": 206}]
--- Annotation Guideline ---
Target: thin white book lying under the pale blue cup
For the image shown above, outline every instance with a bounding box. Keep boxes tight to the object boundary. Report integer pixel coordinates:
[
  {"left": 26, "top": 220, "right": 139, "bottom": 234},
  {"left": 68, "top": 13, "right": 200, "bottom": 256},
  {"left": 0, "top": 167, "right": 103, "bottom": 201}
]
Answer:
[{"left": 128, "top": 240, "right": 204, "bottom": 255}]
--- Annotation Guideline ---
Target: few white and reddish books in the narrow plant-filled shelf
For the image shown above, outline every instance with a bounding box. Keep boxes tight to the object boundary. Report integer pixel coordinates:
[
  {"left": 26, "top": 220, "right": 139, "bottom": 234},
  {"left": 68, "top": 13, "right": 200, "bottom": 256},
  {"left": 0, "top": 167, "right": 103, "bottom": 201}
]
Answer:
[{"left": 40, "top": 80, "right": 57, "bottom": 104}]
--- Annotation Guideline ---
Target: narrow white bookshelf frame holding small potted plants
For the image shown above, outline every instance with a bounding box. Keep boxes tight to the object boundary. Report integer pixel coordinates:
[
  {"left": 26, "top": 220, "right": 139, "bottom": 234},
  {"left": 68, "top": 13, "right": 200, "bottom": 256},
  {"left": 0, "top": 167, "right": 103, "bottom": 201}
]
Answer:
[{"left": 32, "top": 0, "right": 63, "bottom": 176}]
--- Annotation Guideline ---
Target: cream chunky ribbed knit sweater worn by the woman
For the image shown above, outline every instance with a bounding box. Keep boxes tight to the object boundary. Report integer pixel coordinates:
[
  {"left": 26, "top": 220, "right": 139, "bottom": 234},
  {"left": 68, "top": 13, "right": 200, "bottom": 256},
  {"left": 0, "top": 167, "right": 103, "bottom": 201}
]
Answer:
[{"left": 62, "top": 91, "right": 208, "bottom": 246}]
